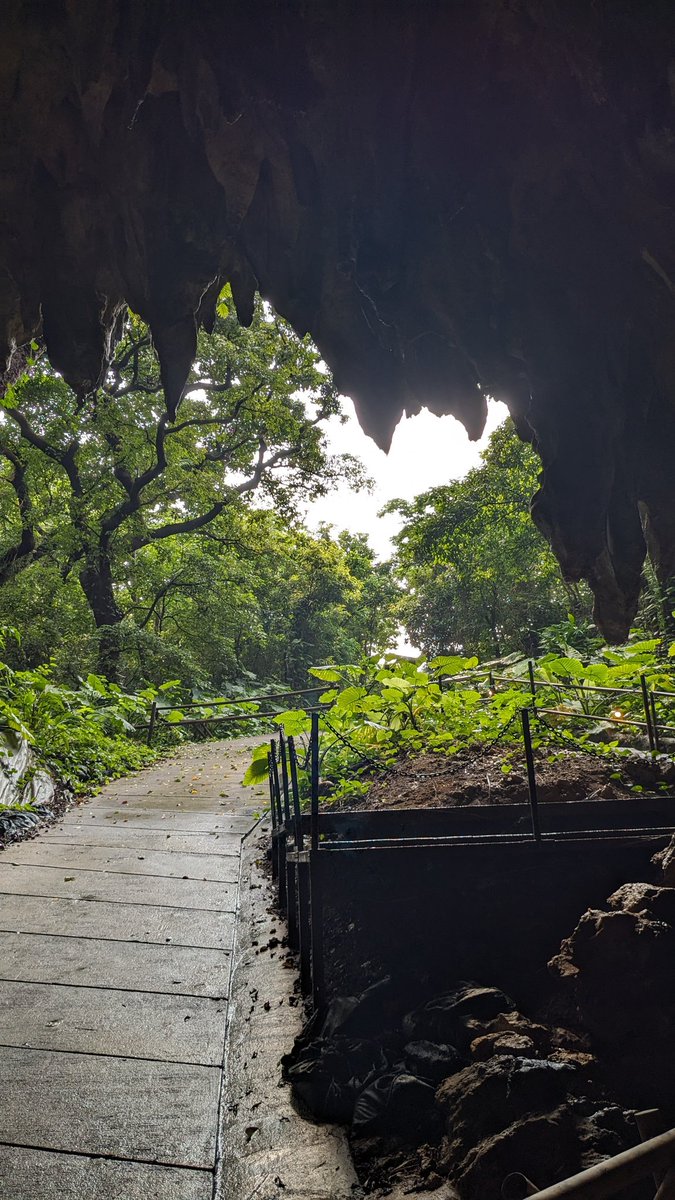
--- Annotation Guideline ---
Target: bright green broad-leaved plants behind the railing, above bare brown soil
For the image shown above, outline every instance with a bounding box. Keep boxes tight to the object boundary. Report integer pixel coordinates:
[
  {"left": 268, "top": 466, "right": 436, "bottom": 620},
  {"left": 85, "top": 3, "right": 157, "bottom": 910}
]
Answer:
[{"left": 245, "top": 637, "right": 675, "bottom": 800}]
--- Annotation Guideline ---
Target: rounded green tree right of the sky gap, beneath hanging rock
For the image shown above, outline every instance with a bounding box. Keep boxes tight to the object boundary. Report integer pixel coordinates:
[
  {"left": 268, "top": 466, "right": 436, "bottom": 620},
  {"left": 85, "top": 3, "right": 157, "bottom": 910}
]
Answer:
[{"left": 386, "top": 421, "right": 589, "bottom": 656}]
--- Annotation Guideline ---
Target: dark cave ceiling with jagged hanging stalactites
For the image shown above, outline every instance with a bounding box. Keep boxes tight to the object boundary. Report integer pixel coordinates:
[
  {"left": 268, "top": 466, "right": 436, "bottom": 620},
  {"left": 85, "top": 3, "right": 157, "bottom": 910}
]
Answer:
[{"left": 0, "top": 0, "right": 675, "bottom": 640}]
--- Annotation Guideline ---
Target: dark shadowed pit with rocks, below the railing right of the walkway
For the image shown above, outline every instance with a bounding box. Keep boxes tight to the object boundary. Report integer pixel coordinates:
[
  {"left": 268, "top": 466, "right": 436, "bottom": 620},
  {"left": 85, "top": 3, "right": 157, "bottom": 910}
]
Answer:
[{"left": 283, "top": 825, "right": 675, "bottom": 1200}]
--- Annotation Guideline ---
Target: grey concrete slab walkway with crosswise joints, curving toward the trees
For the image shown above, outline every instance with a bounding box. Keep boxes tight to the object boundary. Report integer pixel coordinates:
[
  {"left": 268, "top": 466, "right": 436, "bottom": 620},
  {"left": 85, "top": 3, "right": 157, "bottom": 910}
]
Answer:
[{"left": 0, "top": 739, "right": 264, "bottom": 1200}]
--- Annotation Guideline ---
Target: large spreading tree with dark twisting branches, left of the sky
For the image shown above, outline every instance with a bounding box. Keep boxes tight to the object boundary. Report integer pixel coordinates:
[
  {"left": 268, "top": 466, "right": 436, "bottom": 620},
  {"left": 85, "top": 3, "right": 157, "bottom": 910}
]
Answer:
[{"left": 0, "top": 296, "right": 364, "bottom": 678}]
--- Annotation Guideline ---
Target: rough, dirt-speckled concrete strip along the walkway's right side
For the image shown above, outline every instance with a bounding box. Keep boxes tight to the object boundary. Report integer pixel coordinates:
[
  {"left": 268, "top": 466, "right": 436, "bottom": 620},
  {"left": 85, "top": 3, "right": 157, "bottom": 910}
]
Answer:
[{"left": 214, "top": 817, "right": 360, "bottom": 1200}]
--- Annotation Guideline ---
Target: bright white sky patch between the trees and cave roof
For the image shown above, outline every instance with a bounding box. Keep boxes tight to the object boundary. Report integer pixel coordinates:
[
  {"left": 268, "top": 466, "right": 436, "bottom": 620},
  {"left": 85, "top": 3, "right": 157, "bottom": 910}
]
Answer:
[{"left": 302, "top": 397, "right": 508, "bottom": 558}]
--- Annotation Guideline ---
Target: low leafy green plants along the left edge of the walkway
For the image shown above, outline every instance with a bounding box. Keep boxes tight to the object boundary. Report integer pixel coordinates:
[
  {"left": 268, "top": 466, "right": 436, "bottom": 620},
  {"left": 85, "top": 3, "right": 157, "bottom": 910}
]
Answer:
[{"left": 0, "top": 630, "right": 156, "bottom": 792}]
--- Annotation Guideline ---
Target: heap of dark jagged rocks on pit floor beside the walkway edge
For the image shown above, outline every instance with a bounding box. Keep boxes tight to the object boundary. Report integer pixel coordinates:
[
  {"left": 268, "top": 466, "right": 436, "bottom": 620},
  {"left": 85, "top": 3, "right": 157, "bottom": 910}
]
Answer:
[{"left": 285, "top": 983, "right": 640, "bottom": 1200}]
